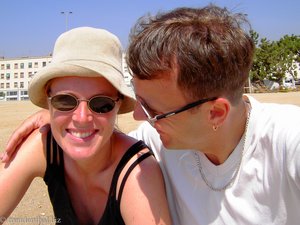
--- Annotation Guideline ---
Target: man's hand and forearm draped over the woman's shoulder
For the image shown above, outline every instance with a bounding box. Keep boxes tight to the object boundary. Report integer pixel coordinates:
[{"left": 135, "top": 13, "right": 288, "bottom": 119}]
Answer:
[{"left": 0, "top": 109, "right": 50, "bottom": 162}]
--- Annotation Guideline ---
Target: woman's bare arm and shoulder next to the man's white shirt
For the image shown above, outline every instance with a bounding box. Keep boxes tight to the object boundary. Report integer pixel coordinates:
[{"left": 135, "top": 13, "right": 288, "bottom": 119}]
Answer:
[{"left": 119, "top": 149, "right": 171, "bottom": 225}]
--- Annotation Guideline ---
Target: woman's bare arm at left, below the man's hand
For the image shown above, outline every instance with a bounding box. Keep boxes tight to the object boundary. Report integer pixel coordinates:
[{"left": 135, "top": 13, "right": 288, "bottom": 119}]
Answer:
[{"left": 0, "top": 131, "right": 46, "bottom": 218}]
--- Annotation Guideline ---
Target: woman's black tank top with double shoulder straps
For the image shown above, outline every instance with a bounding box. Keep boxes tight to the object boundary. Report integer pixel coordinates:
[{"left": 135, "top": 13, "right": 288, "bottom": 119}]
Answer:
[{"left": 44, "top": 132, "right": 153, "bottom": 225}]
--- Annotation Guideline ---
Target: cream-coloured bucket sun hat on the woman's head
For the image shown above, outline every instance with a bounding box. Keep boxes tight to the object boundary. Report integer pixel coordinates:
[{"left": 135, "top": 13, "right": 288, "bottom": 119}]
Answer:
[{"left": 28, "top": 27, "right": 135, "bottom": 114}]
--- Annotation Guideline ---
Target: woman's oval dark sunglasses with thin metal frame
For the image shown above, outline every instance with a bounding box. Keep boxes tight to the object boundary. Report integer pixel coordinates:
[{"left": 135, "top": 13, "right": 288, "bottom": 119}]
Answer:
[{"left": 48, "top": 94, "right": 122, "bottom": 114}]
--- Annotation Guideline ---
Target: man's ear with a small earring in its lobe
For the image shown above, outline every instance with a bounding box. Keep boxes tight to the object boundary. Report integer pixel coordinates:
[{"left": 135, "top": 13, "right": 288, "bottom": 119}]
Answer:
[{"left": 209, "top": 98, "right": 230, "bottom": 129}]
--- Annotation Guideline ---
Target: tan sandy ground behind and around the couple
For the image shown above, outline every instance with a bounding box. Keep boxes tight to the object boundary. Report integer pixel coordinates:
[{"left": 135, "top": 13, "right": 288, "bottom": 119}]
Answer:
[{"left": 0, "top": 92, "right": 300, "bottom": 224}]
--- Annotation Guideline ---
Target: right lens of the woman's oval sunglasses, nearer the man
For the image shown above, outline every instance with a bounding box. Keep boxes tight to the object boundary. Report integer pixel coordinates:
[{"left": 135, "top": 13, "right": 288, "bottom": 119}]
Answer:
[{"left": 89, "top": 96, "right": 115, "bottom": 113}]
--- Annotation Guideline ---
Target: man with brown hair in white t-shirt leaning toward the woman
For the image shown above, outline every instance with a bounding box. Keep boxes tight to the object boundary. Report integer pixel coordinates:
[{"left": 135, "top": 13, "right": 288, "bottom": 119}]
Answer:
[{"left": 2, "top": 5, "right": 300, "bottom": 225}]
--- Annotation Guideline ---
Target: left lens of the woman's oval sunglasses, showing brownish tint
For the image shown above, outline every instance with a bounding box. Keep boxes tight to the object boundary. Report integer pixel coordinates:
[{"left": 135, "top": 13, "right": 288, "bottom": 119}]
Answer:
[{"left": 51, "top": 95, "right": 77, "bottom": 111}]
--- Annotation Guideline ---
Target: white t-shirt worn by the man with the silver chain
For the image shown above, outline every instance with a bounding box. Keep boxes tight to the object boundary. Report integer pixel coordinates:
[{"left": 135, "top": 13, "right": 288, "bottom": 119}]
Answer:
[{"left": 130, "top": 96, "right": 300, "bottom": 225}]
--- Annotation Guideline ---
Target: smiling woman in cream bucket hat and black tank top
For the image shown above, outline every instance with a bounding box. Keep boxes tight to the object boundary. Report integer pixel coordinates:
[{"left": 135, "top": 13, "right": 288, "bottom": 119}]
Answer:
[{"left": 0, "top": 27, "right": 170, "bottom": 225}]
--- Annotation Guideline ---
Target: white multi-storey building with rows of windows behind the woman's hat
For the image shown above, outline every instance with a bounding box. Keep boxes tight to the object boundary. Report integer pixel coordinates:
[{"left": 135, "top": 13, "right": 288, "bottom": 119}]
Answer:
[{"left": 0, "top": 54, "right": 131, "bottom": 101}]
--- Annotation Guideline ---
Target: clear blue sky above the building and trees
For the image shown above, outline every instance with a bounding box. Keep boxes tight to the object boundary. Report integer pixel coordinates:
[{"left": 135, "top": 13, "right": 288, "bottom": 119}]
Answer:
[{"left": 0, "top": 0, "right": 300, "bottom": 58}]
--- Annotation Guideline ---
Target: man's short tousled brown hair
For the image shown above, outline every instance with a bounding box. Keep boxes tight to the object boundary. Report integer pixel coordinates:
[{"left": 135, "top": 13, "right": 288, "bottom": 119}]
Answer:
[{"left": 127, "top": 4, "right": 255, "bottom": 102}]
